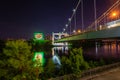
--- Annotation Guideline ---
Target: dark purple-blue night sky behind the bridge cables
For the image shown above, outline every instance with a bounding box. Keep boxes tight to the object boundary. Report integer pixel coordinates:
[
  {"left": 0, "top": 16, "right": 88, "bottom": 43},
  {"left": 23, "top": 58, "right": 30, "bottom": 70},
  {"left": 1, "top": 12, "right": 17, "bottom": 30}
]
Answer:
[{"left": 0, "top": 0, "right": 116, "bottom": 39}]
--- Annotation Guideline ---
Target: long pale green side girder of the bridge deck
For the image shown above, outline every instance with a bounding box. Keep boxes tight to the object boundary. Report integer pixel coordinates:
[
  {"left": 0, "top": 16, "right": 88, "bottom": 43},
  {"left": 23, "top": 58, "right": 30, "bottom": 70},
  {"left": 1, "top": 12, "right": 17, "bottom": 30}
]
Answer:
[{"left": 55, "top": 26, "right": 120, "bottom": 42}]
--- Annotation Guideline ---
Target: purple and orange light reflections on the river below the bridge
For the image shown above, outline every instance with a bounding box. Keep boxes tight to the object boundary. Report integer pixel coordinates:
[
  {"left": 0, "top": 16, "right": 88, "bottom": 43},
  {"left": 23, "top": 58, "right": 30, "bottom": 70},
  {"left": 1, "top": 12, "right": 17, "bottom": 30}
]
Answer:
[{"left": 83, "top": 43, "right": 120, "bottom": 59}]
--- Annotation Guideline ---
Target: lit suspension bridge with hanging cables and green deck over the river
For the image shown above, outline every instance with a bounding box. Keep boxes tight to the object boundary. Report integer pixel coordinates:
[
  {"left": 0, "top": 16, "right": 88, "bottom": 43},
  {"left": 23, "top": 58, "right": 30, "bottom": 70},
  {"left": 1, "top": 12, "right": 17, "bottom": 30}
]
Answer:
[{"left": 55, "top": 0, "right": 120, "bottom": 42}]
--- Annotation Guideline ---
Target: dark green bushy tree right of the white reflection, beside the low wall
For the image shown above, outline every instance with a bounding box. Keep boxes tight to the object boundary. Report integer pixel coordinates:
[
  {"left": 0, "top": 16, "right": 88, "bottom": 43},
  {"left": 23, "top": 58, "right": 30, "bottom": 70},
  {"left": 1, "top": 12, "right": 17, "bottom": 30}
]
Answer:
[{"left": 61, "top": 48, "right": 89, "bottom": 74}]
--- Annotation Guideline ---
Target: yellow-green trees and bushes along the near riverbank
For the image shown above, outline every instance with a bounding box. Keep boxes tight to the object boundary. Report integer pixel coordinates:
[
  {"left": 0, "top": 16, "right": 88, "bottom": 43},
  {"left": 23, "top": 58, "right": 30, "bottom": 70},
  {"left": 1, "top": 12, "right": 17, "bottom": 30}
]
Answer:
[{"left": 0, "top": 40, "right": 105, "bottom": 80}]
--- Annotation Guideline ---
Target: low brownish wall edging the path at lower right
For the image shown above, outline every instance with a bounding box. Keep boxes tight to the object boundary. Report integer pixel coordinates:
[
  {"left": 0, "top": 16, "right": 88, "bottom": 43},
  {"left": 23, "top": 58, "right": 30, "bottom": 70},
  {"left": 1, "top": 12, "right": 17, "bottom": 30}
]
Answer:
[{"left": 49, "top": 62, "right": 120, "bottom": 80}]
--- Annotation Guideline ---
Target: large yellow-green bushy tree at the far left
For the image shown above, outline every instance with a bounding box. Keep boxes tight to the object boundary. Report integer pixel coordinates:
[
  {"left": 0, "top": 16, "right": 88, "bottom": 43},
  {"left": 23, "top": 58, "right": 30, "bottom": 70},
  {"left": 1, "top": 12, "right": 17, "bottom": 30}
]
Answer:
[{"left": 0, "top": 40, "right": 42, "bottom": 80}]
